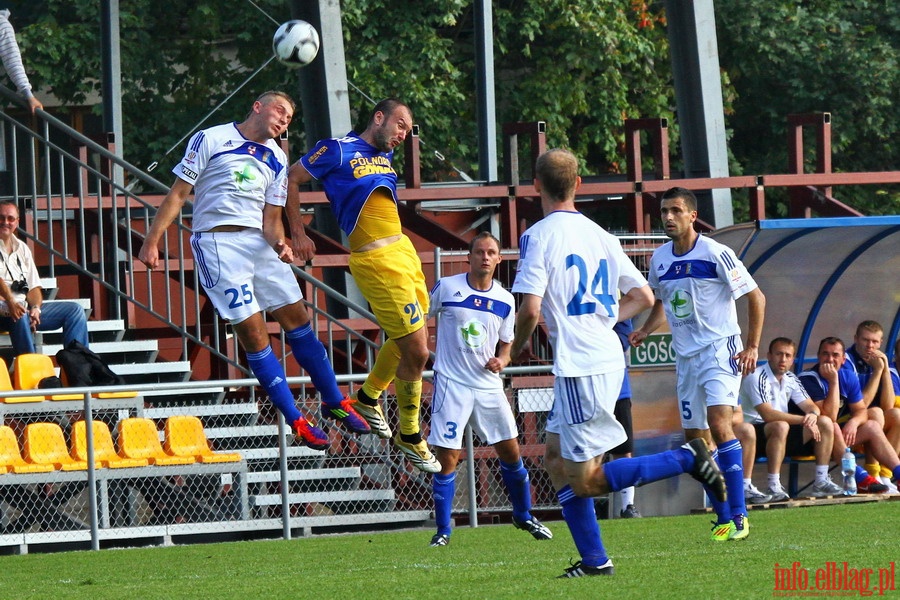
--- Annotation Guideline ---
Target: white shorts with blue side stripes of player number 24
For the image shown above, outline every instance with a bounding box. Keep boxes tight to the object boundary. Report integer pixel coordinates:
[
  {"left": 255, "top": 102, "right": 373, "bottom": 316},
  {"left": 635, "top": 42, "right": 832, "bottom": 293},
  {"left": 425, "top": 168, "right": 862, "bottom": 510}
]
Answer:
[{"left": 547, "top": 369, "right": 627, "bottom": 462}]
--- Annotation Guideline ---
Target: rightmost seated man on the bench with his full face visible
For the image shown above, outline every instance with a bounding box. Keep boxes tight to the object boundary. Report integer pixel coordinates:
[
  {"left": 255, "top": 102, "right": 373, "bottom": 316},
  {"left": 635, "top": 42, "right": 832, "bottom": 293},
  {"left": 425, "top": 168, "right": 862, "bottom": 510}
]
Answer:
[{"left": 847, "top": 321, "right": 900, "bottom": 491}]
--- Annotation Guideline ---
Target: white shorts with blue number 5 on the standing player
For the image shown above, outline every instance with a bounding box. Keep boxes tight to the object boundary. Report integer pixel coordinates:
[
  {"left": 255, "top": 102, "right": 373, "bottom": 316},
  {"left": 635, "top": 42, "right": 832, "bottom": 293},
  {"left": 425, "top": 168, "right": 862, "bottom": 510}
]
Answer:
[{"left": 675, "top": 335, "right": 743, "bottom": 429}]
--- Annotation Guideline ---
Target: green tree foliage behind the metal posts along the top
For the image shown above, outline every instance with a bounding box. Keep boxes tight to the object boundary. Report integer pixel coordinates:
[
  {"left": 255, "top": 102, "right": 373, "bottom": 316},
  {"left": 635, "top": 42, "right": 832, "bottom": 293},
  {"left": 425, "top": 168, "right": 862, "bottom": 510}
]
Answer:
[{"left": 11, "top": 0, "right": 900, "bottom": 213}]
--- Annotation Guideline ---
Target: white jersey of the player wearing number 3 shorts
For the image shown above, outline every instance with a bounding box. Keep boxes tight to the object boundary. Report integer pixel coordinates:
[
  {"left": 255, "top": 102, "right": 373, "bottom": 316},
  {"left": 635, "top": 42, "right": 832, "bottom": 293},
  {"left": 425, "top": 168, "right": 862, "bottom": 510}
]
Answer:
[{"left": 430, "top": 273, "right": 515, "bottom": 390}]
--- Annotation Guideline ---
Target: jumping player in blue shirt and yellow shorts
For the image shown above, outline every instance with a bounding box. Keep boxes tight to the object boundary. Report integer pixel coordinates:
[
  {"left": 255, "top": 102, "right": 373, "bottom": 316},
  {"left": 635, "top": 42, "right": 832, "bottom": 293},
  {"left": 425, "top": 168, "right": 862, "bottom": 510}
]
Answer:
[{"left": 287, "top": 98, "right": 441, "bottom": 473}]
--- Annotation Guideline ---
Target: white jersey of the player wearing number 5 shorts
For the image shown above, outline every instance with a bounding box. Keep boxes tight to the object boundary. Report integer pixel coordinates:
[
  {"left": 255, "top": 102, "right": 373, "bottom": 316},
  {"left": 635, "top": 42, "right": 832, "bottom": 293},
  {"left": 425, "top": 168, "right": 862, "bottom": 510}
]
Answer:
[{"left": 649, "top": 235, "right": 758, "bottom": 357}]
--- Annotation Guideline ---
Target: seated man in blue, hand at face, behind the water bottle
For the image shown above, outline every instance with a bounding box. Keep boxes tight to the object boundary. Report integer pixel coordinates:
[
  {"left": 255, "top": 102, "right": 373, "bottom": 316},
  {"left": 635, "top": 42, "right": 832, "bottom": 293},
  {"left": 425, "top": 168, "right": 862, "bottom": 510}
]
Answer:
[{"left": 800, "top": 337, "right": 900, "bottom": 494}]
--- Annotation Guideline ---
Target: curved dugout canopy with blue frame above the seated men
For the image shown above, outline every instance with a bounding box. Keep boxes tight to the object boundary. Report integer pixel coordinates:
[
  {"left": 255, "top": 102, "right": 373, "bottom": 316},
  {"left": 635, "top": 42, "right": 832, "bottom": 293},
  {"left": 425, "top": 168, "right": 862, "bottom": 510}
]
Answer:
[{"left": 711, "top": 216, "right": 900, "bottom": 364}]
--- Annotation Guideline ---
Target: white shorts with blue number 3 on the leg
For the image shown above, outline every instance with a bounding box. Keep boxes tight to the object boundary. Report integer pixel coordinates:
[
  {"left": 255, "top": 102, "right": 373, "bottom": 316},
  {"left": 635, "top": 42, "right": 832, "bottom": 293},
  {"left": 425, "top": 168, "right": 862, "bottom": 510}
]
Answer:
[{"left": 428, "top": 373, "right": 519, "bottom": 450}]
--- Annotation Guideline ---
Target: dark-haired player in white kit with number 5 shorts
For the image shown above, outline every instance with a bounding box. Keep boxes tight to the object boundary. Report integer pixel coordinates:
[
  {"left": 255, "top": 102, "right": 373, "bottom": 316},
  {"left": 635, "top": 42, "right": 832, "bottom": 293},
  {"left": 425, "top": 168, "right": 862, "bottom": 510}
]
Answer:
[{"left": 630, "top": 188, "right": 766, "bottom": 541}]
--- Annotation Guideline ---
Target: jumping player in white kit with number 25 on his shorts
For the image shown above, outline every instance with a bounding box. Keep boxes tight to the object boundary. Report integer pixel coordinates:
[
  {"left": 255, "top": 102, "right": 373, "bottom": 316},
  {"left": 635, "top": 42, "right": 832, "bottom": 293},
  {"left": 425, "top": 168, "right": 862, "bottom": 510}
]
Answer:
[{"left": 138, "top": 91, "right": 370, "bottom": 450}]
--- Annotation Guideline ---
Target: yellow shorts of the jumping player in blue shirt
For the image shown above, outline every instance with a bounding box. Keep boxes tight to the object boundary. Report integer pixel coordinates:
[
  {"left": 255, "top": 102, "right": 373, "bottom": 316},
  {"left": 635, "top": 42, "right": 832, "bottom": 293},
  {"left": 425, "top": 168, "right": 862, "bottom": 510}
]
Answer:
[{"left": 350, "top": 235, "right": 428, "bottom": 339}]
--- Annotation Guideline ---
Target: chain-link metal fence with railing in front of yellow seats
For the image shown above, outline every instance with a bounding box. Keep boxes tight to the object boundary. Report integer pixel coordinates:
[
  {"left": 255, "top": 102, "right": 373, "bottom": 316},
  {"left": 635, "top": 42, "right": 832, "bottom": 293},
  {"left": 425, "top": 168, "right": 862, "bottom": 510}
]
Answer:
[{"left": 0, "top": 376, "right": 556, "bottom": 552}]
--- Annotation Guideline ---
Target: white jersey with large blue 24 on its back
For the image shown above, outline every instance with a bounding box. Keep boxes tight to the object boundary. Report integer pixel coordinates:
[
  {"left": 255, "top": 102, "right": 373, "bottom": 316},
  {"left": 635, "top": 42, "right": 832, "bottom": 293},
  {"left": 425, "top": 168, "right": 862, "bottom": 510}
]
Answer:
[{"left": 512, "top": 211, "right": 647, "bottom": 377}]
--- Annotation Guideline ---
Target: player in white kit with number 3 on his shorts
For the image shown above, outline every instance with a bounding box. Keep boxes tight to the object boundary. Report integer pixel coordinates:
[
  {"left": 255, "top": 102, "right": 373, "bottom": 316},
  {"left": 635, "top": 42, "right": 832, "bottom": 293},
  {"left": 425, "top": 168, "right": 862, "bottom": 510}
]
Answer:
[{"left": 428, "top": 232, "right": 553, "bottom": 546}]
